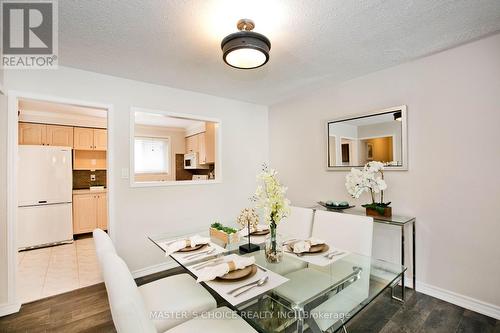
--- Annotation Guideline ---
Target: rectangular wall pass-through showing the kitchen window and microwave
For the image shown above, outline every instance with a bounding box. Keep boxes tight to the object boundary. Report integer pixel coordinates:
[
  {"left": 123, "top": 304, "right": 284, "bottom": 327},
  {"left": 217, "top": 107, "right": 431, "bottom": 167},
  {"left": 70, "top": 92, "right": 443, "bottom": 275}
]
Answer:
[{"left": 130, "top": 108, "right": 221, "bottom": 186}]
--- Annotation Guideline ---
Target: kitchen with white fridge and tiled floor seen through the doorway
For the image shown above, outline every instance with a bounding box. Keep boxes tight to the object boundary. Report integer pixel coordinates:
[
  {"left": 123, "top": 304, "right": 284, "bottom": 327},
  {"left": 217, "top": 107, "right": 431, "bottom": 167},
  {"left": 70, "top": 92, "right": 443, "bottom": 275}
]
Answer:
[{"left": 17, "top": 99, "right": 108, "bottom": 303}]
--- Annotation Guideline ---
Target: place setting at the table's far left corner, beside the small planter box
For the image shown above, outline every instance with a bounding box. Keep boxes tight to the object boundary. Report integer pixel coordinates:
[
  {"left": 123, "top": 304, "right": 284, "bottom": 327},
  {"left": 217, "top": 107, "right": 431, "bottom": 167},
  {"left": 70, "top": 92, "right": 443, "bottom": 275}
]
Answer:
[{"left": 159, "top": 235, "right": 227, "bottom": 263}]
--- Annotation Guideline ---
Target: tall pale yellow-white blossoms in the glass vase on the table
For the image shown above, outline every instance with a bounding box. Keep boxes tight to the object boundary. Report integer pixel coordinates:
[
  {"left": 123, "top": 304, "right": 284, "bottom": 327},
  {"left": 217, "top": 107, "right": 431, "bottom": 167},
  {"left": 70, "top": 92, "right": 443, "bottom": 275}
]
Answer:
[{"left": 252, "top": 165, "right": 290, "bottom": 225}]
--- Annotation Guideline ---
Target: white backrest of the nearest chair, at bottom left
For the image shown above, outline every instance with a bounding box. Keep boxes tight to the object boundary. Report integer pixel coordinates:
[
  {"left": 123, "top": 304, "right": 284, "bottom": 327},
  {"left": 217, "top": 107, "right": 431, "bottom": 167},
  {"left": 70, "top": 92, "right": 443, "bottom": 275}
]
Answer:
[{"left": 102, "top": 252, "right": 156, "bottom": 333}]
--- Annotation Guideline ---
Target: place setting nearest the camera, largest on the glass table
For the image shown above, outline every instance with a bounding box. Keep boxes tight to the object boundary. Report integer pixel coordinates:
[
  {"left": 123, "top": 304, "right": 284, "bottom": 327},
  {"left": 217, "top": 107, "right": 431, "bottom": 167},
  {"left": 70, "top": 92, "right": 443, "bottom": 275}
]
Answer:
[{"left": 186, "top": 254, "right": 288, "bottom": 305}]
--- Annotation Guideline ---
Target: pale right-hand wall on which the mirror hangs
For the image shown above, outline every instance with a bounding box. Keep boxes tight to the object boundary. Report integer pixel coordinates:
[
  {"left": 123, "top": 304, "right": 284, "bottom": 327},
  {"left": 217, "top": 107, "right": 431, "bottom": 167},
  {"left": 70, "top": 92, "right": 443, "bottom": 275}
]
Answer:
[{"left": 269, "top": 35, "right": 500, "bottom": 308}]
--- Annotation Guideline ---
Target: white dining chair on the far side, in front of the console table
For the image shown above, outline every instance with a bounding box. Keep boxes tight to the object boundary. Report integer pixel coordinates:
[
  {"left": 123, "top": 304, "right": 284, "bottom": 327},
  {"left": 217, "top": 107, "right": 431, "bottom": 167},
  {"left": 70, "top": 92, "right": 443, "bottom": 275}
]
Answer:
[{"left": 277, "top": 211, "right": 373, "bottom": 332}]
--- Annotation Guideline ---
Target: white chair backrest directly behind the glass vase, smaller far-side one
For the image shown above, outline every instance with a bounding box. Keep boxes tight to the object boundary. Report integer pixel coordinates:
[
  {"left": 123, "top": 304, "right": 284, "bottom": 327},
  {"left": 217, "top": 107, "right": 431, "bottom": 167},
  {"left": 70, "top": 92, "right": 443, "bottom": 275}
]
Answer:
[{"left": 278, "top": 206, "right": 314, "bottom": 239}]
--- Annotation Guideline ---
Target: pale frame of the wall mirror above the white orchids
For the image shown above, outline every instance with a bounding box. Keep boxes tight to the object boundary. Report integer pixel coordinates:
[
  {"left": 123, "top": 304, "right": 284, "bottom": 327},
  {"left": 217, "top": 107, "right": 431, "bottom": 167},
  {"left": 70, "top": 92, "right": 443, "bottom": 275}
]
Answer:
[{"left": 325, "top": 105, "right": 408, "bottom": 171}]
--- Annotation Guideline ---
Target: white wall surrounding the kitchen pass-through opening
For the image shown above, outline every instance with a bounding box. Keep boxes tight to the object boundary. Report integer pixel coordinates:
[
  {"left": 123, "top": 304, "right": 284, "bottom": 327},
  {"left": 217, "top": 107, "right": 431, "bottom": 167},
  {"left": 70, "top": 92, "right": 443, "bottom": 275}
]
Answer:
[{"left": 0, "top": 67, "right": 268, "bottom": 290}]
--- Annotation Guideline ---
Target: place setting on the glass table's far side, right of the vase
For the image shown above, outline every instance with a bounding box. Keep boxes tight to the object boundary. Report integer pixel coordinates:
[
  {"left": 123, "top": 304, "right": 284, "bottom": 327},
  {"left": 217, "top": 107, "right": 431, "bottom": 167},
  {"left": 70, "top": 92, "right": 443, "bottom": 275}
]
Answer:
[{"left": 282, "top": 238, "right": 349, "bottom": 266}]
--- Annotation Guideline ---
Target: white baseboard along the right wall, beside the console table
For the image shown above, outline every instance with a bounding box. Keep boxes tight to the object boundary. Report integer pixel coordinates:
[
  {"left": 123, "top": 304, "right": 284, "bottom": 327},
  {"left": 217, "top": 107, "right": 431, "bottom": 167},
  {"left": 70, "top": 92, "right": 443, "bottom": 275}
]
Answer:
[{"left": 417, "top": 281, "right": 500, "bottom": 320}]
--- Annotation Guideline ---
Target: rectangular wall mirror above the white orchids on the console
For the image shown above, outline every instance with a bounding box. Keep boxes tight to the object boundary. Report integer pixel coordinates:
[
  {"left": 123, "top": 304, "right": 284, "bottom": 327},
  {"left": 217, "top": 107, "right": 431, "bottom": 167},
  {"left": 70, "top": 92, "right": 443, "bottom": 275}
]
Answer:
[{"left": 327, "top": 105, "right": 408, "bottom": 170}]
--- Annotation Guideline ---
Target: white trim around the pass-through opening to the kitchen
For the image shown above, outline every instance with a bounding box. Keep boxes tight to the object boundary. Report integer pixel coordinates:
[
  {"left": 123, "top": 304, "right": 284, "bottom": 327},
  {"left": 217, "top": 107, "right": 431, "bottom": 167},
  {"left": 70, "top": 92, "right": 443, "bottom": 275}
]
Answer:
[{"left": 129, "top": 106, "right": 222, "bottom": 187}]
